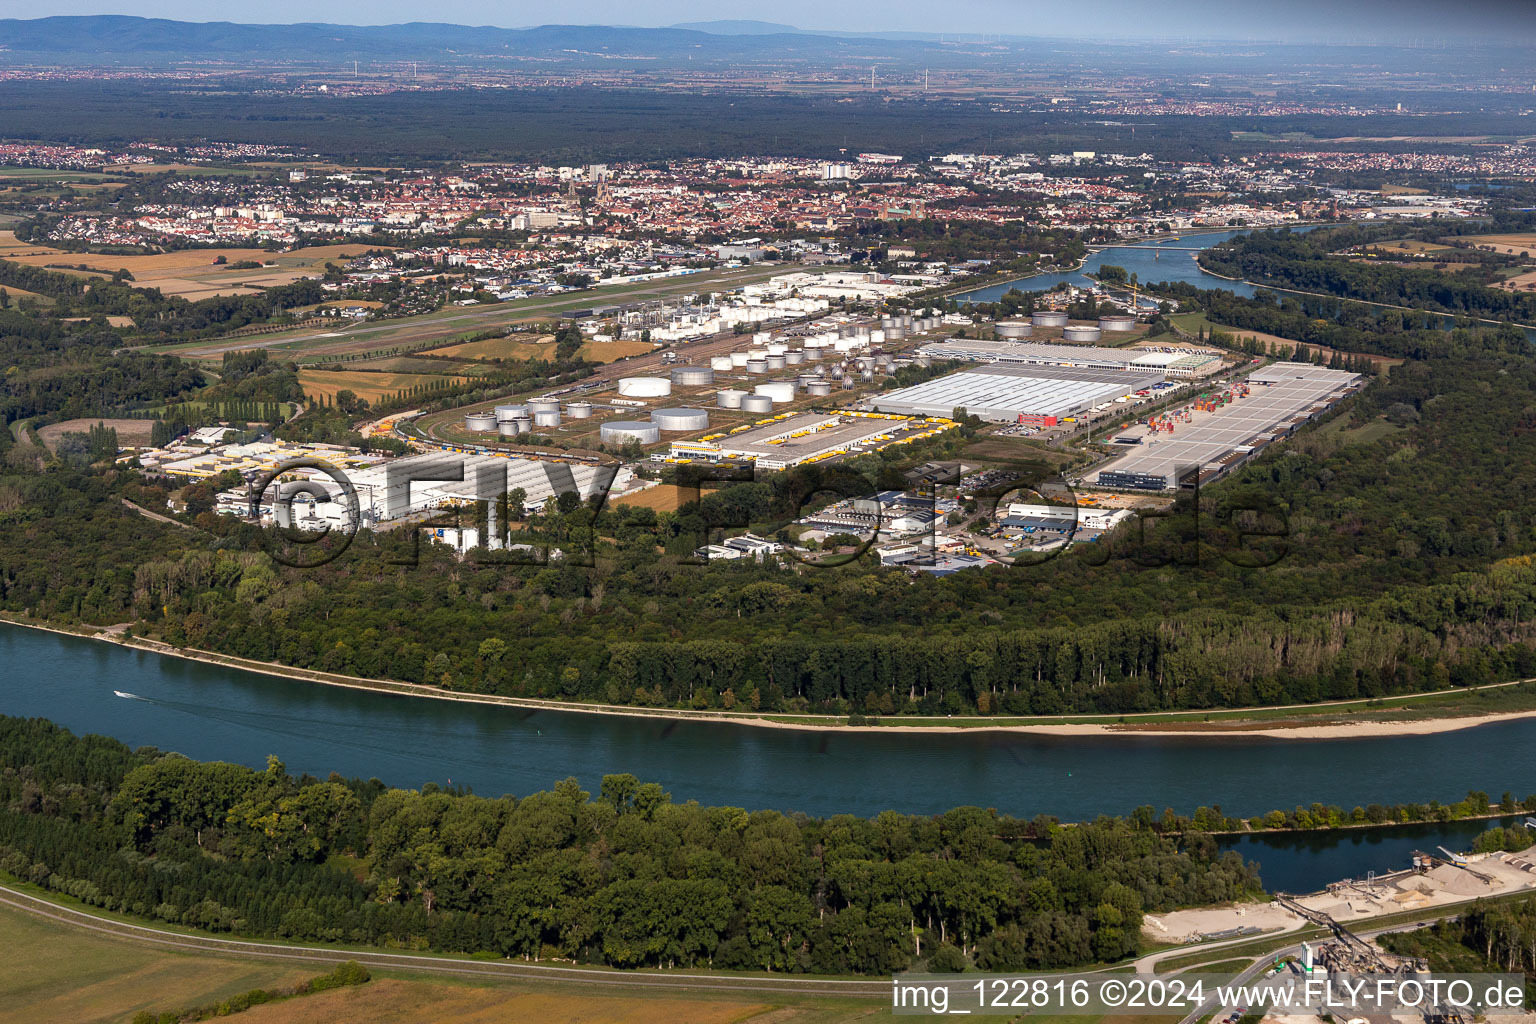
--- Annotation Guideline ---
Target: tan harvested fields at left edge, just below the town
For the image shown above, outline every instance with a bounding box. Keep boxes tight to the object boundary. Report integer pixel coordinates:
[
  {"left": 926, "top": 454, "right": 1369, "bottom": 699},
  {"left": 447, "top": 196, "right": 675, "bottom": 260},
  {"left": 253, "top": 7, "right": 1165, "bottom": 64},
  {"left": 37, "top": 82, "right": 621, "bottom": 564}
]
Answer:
[{"left": 0, "top": 244, "right": 396, "bottom": 299}]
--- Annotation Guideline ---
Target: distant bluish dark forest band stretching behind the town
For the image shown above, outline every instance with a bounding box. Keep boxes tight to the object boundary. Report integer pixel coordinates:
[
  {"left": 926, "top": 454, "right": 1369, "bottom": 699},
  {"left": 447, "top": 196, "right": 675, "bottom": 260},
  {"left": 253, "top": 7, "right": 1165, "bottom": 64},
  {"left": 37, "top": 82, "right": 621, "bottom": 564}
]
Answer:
[{"left": 0, "top": 82, "right": 1511, "bottom": 166}]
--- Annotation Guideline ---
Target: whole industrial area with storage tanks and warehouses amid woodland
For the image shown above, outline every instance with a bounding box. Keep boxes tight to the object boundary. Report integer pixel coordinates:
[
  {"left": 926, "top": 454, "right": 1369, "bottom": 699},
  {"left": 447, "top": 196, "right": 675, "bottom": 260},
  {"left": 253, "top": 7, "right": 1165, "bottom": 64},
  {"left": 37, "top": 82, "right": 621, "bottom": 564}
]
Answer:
[{"left": 113, "top": 264, "right": 1362, "bottom": 573}]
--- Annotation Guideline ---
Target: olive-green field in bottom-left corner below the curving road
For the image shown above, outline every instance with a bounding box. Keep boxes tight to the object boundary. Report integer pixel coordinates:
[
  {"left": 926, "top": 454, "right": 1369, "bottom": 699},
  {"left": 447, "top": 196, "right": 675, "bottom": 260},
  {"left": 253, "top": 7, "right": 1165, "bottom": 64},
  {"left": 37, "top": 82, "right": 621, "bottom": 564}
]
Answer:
[{"left": 0, "top": 907, "right": 311, "bottom": 1024}]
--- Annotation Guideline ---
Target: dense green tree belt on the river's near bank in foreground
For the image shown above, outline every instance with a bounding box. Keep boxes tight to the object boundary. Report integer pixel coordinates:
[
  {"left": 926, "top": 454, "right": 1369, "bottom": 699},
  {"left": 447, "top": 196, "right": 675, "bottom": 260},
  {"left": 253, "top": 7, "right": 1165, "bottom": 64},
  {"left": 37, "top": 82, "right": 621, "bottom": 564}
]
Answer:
[{"left": 0, "top": 718, "right": 1260, "bottom": 973}]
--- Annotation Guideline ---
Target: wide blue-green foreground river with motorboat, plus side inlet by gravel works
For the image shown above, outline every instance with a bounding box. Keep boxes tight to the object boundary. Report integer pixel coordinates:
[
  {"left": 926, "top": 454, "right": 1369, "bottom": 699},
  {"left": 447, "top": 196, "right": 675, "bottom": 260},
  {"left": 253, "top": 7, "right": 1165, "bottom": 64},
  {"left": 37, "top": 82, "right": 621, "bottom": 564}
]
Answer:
[{"left": 0, "top": 625, "right": 1536, "bottom": 890}]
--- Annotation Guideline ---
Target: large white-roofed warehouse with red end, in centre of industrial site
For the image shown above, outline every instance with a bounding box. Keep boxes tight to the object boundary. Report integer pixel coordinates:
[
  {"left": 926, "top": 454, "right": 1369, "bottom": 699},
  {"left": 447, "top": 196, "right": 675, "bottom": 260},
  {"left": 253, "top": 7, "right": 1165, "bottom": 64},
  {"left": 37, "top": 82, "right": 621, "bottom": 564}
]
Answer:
[{"left": 869, "top": 362, "right": 1163, "bottom": 427}]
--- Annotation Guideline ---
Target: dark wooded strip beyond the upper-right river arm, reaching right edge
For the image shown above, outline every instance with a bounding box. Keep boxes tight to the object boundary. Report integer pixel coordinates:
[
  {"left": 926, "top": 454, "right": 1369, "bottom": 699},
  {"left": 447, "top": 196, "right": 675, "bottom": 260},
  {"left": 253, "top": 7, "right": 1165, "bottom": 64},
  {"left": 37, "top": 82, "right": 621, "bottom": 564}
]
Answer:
[{"left": 1200, "top": 224, "right": 1536, "bottom": 324}]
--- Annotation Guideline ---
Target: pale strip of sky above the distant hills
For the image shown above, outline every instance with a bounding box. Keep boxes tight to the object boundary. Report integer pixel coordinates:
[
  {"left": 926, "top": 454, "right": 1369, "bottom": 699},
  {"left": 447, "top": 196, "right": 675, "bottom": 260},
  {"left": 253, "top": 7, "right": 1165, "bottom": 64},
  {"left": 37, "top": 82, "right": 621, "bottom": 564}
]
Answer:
[{"left": 21, "top": 0, "right": 1536, "bottom": 44}]
